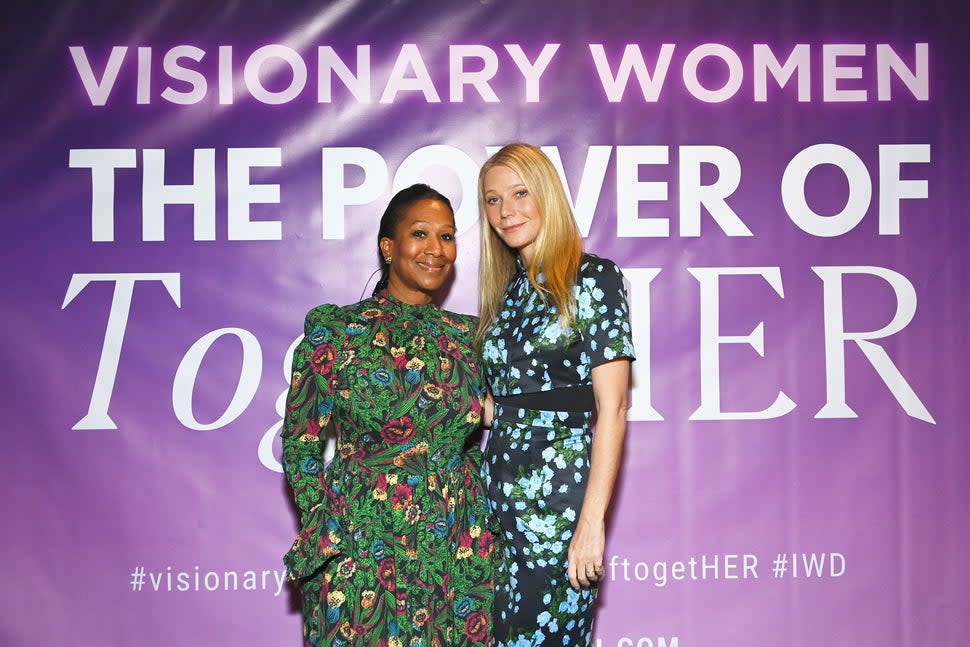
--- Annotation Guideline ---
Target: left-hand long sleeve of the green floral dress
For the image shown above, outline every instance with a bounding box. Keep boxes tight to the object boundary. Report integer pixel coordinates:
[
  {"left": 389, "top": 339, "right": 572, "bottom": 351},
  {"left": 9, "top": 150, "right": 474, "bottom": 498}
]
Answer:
[{"left": 281, "top": 305, "right": 338, "bottom": 526}]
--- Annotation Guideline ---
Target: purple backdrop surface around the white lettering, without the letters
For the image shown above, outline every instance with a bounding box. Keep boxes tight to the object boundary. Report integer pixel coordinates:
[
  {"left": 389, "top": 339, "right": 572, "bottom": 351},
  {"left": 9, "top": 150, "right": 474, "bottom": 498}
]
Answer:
[{"left": 0, "top": 0, "right": 970, "bottom": 647}]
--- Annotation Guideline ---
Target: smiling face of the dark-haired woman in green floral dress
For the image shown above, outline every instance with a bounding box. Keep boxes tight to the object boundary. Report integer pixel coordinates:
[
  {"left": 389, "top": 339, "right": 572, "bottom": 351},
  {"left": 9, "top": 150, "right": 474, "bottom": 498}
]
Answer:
[{"left": 380, "top": 199, "right": 458, "bottom": 304}]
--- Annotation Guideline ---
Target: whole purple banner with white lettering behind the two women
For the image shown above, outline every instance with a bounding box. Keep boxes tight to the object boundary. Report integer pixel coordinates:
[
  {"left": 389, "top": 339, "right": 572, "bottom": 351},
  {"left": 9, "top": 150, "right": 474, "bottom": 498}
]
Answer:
[{"left": 0, "top": 0, "right": 970, "bottom": 647}]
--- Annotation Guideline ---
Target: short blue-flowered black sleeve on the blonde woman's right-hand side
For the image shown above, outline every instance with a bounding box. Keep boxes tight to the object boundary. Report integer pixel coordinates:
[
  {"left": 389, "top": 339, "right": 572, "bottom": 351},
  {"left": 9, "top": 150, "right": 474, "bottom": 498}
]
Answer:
[{"left": 577, "top": 256, "right": 636, "bottom": 368}]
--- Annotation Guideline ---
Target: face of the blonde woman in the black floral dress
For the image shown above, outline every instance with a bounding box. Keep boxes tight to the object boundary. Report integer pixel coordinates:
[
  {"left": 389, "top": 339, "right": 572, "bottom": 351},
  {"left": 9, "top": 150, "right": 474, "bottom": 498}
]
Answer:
[{"left": 482, "top": 166, "right": 542, "bottom": 266}]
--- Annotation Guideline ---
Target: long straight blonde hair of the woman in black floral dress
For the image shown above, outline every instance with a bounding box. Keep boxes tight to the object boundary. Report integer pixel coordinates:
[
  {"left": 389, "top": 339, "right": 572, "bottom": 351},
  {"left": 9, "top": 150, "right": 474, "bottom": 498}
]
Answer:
[{"left": 475, "top": 143, "right": 583, "bottom": 344}]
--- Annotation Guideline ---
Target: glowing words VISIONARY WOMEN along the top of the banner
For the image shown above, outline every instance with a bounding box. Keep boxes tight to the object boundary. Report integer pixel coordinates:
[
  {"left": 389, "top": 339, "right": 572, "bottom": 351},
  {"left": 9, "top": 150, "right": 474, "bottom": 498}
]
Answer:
[{"left": 69, "top": 43, "right": 930, "bottom": 106}]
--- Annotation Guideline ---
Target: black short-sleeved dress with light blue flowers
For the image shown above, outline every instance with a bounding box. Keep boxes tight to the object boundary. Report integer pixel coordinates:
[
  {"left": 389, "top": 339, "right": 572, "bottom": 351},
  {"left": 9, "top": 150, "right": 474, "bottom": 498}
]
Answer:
[{"left": 482, "top": 255, "right": 634, "bottom": 646}]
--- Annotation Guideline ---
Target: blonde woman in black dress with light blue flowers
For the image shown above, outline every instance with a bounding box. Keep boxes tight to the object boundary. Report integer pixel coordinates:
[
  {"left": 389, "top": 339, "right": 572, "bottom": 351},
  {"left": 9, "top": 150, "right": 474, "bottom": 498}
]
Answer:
[{"left": 477, "top": 144, "right": 634, "bottom": 645}]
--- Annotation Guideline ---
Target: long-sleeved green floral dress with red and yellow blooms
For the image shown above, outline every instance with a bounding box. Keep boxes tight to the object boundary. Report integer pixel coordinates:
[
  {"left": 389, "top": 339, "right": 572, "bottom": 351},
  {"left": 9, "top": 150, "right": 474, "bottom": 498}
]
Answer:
[{"left": 282, "top": 294, "right": 495, "bottom": 647}]
